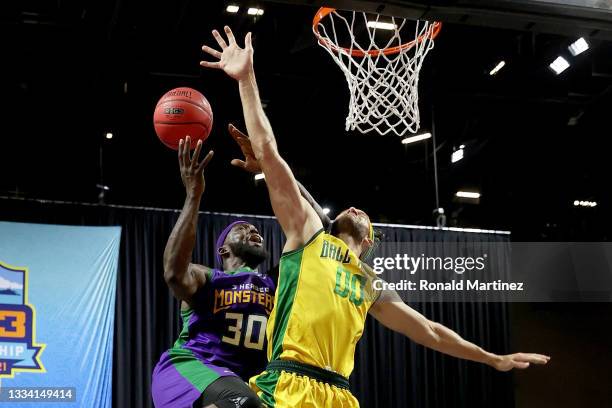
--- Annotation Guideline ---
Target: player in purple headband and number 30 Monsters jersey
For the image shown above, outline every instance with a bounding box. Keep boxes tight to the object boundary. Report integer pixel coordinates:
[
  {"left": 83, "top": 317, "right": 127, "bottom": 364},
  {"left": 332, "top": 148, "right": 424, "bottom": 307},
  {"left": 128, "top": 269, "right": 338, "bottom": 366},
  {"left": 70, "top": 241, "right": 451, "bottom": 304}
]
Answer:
[{"left": 152, "top": 134, "right": 330, "bottom": 408}]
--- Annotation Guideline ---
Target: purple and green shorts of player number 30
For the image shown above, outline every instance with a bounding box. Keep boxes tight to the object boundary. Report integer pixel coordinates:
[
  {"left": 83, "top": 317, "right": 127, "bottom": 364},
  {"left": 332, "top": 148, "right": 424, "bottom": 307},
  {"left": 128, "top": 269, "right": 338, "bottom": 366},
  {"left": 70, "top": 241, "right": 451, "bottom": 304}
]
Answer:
[{"left": 151, "top": 348, "right": 236, "bottom": 408}]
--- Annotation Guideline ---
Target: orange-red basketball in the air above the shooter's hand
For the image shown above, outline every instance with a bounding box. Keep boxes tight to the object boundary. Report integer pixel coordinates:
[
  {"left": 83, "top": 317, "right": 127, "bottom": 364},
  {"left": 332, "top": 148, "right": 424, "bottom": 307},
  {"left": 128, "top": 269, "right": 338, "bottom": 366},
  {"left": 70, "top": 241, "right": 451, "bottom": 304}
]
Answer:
[{"left": 153, "top": 88, "right": 213, "bottom": 150}]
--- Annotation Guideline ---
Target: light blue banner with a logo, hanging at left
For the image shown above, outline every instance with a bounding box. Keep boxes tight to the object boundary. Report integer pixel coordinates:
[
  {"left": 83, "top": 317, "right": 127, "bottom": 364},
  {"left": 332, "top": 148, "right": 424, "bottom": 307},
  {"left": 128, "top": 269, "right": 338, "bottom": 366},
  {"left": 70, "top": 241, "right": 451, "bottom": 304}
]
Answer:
[{"left": 0, "top": 222, "right": 121, "bottom": 408}]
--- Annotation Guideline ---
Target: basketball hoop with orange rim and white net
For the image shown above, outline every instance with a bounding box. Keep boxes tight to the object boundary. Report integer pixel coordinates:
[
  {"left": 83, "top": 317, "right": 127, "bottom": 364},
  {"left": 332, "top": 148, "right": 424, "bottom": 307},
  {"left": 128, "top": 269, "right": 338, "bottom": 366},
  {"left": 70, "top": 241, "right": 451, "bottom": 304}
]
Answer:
[{"left": 312, "top": 7, "right": 442, "bottom": 136}]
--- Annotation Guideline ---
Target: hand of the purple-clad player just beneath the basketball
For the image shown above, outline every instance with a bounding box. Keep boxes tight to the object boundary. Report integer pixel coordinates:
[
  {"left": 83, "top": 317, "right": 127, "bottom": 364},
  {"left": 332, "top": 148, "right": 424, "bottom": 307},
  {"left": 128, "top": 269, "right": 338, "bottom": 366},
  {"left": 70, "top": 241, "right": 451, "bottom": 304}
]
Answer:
[{"left": 178, "top": 136, "right": 214, "bottom": 198}]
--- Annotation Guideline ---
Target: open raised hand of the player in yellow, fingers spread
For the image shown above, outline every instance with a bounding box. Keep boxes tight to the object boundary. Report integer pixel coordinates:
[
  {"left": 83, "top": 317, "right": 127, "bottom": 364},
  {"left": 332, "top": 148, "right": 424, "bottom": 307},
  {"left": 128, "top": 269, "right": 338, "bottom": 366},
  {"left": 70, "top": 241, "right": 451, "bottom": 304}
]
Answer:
[{"left": 200, "top": 26, "right": 253, "bottom": 80}]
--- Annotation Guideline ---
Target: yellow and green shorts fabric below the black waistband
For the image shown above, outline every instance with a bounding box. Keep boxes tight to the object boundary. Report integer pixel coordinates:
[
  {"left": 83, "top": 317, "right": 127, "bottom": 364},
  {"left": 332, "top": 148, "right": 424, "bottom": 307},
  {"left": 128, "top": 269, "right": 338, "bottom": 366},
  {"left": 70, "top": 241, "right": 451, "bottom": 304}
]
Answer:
[{"left": 250, "top": 371, "right": 359, "bottom": 408}]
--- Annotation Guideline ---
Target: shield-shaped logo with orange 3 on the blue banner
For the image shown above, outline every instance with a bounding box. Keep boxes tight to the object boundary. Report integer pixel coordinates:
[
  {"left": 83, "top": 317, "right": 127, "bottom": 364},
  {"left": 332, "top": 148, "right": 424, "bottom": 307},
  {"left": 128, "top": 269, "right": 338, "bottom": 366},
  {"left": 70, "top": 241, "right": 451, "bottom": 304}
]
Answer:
[{"left": 0, "top": 261, "right": 45, "bottom": 378}]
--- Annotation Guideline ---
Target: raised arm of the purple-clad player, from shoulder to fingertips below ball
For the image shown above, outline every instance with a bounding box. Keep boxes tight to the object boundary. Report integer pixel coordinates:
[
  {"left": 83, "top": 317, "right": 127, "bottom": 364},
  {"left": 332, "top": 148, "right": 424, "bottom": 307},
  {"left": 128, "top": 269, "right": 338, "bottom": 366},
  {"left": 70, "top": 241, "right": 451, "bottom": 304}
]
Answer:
[{"left": 164, "top": 136, "right": 213, "bottom": 303}]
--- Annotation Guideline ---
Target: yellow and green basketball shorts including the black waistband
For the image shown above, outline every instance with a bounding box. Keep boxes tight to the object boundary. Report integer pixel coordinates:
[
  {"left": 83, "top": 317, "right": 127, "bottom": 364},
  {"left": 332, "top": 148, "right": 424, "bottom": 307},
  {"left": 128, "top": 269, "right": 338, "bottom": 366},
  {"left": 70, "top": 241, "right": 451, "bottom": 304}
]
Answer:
[{"left": 250, "top": 360, "right": 359, "bottom": 408}]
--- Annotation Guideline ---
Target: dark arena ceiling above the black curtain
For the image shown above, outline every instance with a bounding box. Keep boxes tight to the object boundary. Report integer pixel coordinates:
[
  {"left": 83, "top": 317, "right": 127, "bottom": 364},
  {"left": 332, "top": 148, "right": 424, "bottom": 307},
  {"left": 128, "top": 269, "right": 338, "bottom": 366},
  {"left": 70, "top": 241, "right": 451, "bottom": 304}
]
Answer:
[{"left": 0, "top": 0, "right": 612, "bottom": 239}]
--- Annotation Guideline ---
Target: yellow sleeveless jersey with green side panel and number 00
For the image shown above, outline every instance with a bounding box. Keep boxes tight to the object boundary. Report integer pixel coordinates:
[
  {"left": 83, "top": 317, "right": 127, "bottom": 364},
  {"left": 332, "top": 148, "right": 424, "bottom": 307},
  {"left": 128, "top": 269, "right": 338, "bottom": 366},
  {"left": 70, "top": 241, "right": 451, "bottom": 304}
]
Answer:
[{"left": 266, "top": 230, "right": 378, "bottom": 378}]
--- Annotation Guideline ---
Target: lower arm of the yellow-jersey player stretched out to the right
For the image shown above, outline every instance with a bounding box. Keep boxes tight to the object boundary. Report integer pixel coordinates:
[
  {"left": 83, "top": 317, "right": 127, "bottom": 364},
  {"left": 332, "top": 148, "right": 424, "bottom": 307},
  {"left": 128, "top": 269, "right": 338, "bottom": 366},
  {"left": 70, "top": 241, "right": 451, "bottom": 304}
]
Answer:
[{"left": 370, "top": 291, "right": 550, "bottom": 371}]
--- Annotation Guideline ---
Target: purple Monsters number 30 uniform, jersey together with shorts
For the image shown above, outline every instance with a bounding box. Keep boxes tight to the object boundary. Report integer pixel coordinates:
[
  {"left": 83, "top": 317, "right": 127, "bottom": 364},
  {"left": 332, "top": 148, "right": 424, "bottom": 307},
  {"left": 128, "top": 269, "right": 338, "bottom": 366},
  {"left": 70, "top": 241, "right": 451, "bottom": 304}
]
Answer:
[{"left": 151, "top": 268, "right": 275, "bottom": 408}]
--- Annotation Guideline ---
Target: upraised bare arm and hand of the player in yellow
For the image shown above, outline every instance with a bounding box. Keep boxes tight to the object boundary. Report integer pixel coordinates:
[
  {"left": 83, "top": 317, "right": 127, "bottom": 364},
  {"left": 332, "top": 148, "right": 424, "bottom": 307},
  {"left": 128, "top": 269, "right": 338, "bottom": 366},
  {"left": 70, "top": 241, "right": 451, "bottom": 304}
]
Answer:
[{"left": 200, "top": 26, "right": 322, "bottom": 251}]
